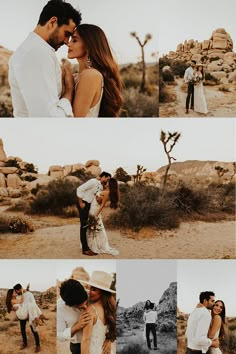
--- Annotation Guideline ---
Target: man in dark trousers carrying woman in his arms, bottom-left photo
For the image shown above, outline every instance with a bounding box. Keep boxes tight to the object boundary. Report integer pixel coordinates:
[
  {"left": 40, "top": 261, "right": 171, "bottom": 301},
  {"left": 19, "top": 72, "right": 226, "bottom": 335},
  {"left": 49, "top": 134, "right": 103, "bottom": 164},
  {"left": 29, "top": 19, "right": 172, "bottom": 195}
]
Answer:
[{"left": 13, "top": 284, "right": 40, "bottom": 353}]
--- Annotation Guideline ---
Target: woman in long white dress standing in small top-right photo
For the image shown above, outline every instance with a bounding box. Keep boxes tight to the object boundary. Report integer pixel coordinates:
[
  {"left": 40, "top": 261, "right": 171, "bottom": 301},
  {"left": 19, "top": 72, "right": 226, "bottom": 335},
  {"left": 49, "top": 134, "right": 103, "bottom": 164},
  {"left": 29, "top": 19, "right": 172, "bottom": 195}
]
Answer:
[{"left": 194, "top": 63, "right": 208, "bottom": 114}]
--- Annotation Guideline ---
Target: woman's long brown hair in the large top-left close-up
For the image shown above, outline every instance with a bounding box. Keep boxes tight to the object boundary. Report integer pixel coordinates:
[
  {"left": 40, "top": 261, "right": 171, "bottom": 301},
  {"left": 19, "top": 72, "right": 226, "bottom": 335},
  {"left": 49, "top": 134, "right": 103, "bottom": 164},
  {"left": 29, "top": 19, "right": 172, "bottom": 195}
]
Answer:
[{"left": 77, "top": 24, "right": 123, "bottom": 117}]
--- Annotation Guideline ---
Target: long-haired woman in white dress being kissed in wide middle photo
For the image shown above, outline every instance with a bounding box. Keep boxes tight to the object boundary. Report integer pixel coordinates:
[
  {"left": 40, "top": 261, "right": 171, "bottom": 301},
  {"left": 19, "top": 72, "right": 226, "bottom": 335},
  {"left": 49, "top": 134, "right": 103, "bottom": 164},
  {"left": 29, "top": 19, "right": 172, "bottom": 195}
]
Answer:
[{"left": 87, "top": 178, "right": 119, "bottom": 256}]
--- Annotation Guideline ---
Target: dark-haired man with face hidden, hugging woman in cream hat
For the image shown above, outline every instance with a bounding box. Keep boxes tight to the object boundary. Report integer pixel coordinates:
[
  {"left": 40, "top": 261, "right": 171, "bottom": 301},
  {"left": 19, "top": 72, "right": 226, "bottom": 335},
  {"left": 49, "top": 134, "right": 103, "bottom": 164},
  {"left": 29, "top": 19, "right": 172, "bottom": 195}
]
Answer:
[{"left": 57, "top": 279, "right": 110, "bottom": 354}]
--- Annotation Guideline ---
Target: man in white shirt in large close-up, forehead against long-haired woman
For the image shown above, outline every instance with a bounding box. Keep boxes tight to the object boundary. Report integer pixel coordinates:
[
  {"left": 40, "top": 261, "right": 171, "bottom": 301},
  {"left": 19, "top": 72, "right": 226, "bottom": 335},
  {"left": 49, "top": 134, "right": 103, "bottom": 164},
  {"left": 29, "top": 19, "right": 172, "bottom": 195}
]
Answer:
[{"left": 9, "top": 0, "right": 81, "bottom": 118}]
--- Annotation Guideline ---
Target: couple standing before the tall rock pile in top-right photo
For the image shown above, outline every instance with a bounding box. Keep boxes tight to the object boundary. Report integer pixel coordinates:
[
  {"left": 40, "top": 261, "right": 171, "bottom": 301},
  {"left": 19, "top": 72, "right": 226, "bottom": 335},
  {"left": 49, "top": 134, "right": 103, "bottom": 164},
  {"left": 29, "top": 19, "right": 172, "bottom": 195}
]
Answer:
[{"left": 184, "top": 60, "right": 208, "bottom": 115}]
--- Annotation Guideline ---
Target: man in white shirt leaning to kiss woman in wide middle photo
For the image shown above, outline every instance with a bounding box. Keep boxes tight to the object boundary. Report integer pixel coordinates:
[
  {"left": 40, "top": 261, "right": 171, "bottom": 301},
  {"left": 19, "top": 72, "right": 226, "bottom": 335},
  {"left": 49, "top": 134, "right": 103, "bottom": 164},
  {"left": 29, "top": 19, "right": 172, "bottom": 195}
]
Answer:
[{"left": 76, "top": 172, "right": 111, "bottom": 256}]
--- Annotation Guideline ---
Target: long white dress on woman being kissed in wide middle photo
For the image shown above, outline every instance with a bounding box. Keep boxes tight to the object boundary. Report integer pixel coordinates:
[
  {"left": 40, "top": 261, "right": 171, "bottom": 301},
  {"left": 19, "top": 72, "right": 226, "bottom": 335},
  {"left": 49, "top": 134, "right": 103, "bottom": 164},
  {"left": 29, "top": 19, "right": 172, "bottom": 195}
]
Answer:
[{"left": 87, "top": 193, "right": 119, "bottom": 256}]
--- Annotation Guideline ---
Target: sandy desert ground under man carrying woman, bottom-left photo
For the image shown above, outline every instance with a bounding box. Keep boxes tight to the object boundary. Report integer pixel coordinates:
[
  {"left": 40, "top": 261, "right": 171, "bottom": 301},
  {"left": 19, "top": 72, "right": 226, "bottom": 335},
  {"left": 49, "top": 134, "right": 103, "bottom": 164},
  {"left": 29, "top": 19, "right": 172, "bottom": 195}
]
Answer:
[{"left": 0, "top": 304, "right": 56, "bottom": 354}]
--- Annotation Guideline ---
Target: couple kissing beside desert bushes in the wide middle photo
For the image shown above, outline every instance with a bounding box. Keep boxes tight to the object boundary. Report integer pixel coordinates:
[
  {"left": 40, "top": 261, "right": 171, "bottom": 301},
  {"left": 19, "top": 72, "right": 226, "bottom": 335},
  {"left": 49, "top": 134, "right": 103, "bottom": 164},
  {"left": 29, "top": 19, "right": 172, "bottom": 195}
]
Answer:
[{"left": 77, "top": 172, "right": 119, "bottom": 256}]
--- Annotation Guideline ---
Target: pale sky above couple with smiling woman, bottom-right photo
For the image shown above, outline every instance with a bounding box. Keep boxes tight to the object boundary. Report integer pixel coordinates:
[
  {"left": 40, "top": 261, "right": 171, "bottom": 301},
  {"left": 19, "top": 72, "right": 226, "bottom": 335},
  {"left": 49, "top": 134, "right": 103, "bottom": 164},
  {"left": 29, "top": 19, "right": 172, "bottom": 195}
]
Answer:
[{"left": 177, "top": 260, "right": 236, "bottom": 317}]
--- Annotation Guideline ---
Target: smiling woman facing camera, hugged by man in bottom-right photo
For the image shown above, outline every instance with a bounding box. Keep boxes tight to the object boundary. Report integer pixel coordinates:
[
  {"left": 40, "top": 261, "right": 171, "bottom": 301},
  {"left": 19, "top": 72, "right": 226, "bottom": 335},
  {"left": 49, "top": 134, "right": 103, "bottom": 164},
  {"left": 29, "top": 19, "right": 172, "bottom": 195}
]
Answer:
[{"left": 208, "top": 300, "right": 225, "bottom": 354}]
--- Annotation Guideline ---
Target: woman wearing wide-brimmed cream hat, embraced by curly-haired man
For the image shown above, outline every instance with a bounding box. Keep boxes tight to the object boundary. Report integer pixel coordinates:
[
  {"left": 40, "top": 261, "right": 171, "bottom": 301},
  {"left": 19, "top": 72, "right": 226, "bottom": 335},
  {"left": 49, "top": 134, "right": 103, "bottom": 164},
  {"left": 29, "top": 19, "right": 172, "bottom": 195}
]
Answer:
[{"left": 80, "top": 271, "right": 116, "bottom": 354}]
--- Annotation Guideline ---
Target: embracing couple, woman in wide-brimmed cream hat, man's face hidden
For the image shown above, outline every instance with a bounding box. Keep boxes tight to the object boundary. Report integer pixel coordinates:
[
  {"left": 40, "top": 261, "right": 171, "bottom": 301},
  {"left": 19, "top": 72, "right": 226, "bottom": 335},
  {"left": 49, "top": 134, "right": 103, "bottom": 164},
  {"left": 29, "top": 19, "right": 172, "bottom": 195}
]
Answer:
[{"left": 57, "top": 271, "right": 116, "bottom": 354}]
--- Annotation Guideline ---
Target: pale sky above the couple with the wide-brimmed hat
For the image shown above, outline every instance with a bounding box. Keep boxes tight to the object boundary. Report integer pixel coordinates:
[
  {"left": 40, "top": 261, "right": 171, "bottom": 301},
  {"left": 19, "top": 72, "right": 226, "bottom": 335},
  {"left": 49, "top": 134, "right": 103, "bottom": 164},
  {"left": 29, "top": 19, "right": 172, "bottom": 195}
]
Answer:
[{"left": 56, "top": 259, "right": 116, "bottom": 281}]
